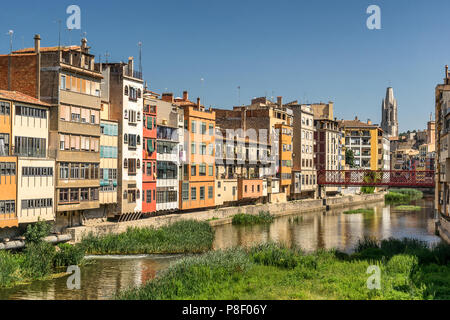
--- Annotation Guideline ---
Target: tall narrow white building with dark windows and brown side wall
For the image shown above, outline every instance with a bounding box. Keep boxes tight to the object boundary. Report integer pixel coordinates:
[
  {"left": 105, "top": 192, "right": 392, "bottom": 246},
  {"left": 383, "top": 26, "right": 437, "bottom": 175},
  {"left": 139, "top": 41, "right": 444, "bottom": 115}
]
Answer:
[{"left": 98, "top": 57, "right": 143, "bottom": 221}]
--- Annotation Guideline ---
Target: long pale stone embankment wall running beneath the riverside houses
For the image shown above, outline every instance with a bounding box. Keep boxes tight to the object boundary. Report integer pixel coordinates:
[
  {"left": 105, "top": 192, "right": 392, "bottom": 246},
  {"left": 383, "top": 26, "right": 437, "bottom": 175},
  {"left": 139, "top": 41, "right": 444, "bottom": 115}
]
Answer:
[{"left": 67, "top": 193, "right": 384, "bottom": 242}]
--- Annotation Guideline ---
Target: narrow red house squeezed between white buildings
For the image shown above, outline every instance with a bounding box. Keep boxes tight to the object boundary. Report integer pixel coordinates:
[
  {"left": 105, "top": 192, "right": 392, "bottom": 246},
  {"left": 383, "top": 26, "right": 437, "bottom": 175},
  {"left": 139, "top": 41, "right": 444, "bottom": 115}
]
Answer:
[{"left": 142, "top": 91, "right": 157, "bottom": 215}]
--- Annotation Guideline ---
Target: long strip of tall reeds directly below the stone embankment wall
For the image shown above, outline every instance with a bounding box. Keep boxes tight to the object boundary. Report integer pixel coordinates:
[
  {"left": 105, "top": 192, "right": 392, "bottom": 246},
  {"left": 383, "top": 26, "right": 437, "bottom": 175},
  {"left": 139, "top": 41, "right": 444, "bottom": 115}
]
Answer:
[{"left": 79, "top": 220, "right": 214, "bottom": 255}]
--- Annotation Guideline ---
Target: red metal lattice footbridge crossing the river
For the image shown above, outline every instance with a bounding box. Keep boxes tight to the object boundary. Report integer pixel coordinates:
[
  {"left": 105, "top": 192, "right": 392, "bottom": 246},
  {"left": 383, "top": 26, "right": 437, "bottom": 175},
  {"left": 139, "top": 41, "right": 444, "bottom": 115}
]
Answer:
[{"left": 317, "top": 170, "right": 435, "bottom": 188}]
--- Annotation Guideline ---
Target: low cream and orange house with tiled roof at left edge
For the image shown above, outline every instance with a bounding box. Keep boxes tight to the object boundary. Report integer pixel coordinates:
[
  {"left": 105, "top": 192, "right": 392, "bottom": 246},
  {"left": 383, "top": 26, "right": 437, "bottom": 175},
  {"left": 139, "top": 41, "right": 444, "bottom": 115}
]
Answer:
[{"left": 0, "top": 90, "right": 55, "bottom": 232}]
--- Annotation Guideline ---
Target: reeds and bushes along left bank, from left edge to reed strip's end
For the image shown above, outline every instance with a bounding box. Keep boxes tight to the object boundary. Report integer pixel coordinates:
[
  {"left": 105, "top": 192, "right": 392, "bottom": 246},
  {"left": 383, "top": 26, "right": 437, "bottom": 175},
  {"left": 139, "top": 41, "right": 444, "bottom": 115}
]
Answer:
[{"left": 0, "top": 221, "right": 214, "bottom": 287}]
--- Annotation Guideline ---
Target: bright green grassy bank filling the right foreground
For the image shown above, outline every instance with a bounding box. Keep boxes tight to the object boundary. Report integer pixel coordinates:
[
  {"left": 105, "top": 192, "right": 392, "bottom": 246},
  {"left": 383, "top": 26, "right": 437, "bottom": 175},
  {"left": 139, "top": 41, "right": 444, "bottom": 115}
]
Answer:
[{"left": 117, "top": 239, "right": 450, "bottom": 300}]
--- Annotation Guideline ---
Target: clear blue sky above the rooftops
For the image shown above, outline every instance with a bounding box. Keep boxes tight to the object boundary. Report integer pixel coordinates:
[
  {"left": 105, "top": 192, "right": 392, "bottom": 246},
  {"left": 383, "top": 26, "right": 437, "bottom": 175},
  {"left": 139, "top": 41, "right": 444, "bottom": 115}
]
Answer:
[{"left": 0, "top": 0, "right": 450, "bottom": 131}]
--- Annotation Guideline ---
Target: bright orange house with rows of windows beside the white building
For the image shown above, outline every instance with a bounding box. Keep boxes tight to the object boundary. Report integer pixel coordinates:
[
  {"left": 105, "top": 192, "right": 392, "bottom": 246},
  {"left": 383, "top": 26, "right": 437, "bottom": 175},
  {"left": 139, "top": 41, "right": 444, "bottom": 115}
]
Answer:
[{"left": 162, "top": 91, "right": 216, "bottom": 211}]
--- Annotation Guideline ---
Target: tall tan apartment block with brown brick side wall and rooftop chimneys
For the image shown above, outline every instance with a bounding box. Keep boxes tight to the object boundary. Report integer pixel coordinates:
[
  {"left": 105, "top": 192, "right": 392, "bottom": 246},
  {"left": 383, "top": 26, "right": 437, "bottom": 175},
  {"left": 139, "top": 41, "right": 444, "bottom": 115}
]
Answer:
[{"left": 0, "top": 35, "right": 103, "bottom": 229}]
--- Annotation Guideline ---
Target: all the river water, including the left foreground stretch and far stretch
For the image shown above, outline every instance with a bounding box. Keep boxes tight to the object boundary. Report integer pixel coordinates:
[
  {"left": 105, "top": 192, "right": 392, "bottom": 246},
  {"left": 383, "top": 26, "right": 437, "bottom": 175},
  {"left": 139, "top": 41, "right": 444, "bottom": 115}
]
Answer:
[{"left": 0, "top": 198, "right": 440, "bottom": 300}]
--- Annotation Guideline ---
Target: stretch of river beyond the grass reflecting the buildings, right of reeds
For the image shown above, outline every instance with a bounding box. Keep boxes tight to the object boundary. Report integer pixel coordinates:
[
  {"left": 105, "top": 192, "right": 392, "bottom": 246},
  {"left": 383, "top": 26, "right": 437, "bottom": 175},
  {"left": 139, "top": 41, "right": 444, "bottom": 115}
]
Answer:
[{"left": 214, "top": 203, "right": 435, "bottom": 252}]
